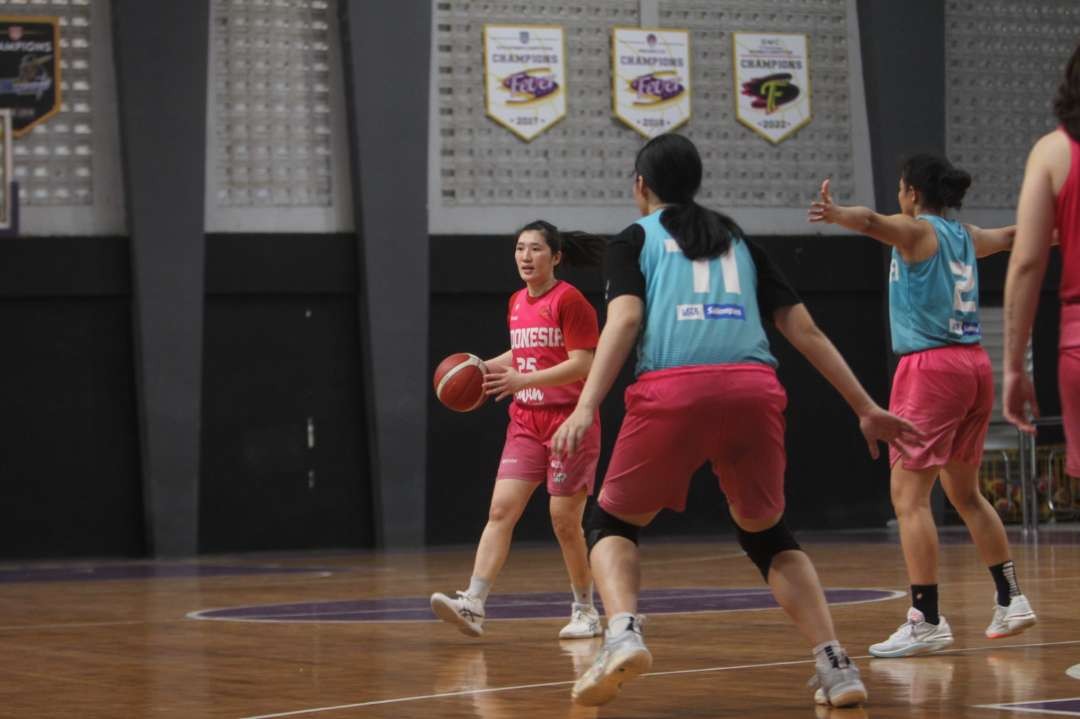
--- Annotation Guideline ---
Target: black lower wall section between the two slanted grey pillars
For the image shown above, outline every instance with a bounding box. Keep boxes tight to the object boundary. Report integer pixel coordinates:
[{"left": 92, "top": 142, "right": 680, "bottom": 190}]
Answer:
[{"left": 199, "top": 233, "right": 373, "bottom": 552}]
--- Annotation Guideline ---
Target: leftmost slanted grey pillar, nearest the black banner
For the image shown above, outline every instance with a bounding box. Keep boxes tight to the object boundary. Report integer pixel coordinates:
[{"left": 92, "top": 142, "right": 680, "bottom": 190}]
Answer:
[{"left": 112, "top": 0, "right": 210, "bottom": 556}]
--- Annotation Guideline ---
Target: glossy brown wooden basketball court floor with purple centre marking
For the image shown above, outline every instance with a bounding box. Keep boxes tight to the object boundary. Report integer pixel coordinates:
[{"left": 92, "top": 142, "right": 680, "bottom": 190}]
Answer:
[{"left": 0, "top": 530, "right": 1080, "bottom": 719}]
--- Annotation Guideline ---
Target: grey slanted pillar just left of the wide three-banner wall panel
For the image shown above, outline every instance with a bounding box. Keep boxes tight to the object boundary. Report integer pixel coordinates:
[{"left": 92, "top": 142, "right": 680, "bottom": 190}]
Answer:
[{"left": 339, "top": 0, "right": 431, "bottom": 547}]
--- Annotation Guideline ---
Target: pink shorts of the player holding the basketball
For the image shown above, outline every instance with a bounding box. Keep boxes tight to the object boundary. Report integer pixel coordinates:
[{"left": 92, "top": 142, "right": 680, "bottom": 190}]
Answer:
[{"left": 495, "top": 402, "right": 600, "bottom": 497}]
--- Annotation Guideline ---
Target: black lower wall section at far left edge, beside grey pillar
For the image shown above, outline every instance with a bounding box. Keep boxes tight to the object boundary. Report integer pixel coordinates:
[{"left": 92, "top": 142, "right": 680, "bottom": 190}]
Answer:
[{"left": 0, "top": 236, "right": 146, "bottom": 559}]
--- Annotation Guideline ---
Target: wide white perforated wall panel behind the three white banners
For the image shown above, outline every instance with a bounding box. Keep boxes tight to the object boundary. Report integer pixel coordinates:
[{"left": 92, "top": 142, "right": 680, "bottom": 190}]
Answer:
[{"left": 429, "top": 0, "right": 873, "bottom": 233}]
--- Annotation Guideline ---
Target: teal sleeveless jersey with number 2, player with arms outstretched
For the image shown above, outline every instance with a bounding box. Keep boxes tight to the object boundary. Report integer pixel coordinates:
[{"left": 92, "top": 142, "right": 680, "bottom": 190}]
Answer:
[{"left": 889, "top": 215, "right": 982, "bottom": 354}]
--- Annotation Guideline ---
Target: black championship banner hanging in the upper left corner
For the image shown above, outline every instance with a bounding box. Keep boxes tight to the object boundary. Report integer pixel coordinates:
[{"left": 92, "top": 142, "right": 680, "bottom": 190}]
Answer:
[{"left": 0, "top": 15, "right": 60, "bottom": 137}]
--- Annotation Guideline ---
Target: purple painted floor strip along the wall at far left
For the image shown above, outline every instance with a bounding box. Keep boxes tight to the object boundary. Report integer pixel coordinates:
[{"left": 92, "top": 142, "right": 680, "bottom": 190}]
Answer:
[{"left": 0, "top": 562, "right": 334, "bottom": 584}]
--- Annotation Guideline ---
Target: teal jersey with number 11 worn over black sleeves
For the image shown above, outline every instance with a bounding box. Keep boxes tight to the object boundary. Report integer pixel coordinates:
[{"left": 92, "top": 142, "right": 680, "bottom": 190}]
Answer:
[{"left": 637, "top": 209, "right": 777, "bottom": 375}]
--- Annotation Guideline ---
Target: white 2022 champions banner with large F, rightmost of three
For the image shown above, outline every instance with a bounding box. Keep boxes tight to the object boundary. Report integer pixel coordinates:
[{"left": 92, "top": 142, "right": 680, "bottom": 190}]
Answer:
[{"left": 731, "top": 32, "right": 810, "bottom": 144}]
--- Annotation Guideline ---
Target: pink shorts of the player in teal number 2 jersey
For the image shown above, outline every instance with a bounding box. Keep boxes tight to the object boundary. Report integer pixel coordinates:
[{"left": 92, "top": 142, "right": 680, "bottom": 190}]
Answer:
[{"left": 889, "top": 344, "right": 994, "bottom": 471}]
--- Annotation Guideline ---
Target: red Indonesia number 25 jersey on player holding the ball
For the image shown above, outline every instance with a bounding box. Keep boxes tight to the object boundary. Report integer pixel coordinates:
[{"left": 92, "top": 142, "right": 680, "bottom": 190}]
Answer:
[{"left": 507, "top": 280, "right": 600, "bottom": 407}]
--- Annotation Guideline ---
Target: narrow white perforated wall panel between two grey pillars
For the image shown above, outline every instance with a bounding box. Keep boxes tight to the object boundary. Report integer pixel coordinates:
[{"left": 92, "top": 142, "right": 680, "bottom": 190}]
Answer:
[{"left": 206, "top": 0, "right": 352, "bottom": 232}]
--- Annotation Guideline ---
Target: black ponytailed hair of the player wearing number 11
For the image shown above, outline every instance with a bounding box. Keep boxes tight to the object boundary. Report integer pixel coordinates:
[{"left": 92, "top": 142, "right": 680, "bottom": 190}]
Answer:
[{"left": 634, "top": 133, "right": 742, "bottom": 260}]
